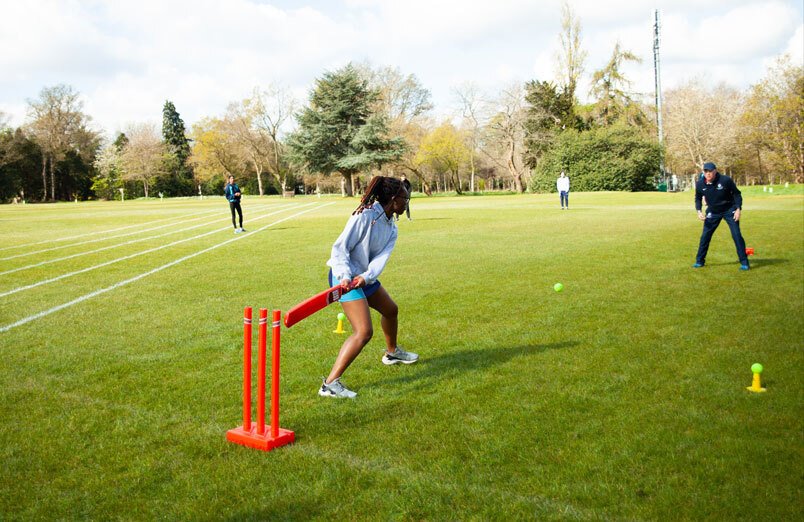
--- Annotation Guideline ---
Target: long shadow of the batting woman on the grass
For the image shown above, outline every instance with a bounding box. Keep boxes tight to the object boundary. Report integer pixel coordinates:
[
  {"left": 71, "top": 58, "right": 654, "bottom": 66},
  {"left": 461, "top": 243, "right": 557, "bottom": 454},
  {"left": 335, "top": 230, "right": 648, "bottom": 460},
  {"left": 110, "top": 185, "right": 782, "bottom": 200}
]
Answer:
[{"left": 368, "top": 341, "right": 579, "bottom": 386}]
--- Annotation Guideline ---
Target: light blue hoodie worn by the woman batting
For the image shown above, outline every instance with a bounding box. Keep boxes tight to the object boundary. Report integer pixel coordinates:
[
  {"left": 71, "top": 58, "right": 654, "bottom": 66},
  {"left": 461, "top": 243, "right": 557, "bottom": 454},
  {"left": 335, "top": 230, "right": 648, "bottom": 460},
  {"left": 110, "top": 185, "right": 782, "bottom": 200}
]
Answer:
[{"left": 327, "top": 202, "right": 397, "bottom": 285}]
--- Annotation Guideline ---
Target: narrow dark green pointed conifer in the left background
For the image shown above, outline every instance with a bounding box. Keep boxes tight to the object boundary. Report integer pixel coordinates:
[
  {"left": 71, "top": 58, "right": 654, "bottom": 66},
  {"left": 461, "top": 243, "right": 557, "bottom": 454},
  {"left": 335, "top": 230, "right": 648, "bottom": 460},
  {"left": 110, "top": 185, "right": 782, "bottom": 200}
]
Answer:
[{"left": 157, "top": 100, "right": 193, "bottom": 196}]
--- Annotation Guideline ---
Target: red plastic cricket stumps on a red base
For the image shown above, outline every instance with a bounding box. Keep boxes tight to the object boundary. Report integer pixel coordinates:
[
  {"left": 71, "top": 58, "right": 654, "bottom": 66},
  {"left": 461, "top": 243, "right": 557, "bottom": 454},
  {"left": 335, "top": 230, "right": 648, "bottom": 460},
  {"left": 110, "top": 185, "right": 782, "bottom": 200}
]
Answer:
[{"left": 226, "top": 306, "right": 296, "bottom": 451}]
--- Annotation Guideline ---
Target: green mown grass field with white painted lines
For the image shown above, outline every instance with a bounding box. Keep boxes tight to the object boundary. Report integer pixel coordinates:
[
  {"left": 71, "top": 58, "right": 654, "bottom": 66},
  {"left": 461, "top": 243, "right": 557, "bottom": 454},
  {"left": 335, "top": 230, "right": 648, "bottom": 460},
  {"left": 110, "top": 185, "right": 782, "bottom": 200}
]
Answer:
[{"left": 0, "top": 189, "right": 804, "bottom": 520}]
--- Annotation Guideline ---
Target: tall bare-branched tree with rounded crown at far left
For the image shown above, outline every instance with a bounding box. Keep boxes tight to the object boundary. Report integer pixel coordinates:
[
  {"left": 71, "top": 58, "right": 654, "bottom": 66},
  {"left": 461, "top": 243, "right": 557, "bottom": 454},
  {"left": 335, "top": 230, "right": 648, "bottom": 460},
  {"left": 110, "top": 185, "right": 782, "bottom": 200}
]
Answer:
[{"left": 28, "top": 84, "right": 94, "bottom": 201}]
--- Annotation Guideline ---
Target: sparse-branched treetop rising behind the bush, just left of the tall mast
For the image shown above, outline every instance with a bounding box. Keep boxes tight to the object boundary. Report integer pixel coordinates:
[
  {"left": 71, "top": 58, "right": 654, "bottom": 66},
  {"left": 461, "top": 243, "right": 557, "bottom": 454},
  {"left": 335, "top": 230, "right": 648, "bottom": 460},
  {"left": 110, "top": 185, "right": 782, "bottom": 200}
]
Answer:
[{"left": 590, "top": 41, "right": 646, "bottom": 127}]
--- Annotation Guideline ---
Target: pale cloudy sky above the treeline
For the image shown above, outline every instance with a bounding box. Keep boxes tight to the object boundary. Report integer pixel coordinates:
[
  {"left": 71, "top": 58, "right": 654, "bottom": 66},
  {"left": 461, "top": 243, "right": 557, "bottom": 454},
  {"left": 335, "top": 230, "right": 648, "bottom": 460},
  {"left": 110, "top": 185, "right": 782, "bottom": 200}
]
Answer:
[{"left": 0, "top": 0, "right": 804, "bottom": 139}]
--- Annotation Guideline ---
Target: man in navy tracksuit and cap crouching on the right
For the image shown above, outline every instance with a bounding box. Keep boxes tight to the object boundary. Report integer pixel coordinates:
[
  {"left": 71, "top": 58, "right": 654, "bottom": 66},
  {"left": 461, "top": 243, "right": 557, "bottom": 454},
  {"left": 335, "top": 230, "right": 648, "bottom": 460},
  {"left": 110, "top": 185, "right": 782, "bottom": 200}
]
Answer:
[{"left": 692, "top": 162, "right": 749, "bottom": 270}]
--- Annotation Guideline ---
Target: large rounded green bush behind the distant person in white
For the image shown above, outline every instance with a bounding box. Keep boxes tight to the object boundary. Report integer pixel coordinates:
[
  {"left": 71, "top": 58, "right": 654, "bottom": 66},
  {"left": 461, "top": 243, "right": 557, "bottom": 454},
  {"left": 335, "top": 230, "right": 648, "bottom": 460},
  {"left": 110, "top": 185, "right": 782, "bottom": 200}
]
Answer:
[{"left": 529, "top": 125, "right": 661, "bottom": 192}]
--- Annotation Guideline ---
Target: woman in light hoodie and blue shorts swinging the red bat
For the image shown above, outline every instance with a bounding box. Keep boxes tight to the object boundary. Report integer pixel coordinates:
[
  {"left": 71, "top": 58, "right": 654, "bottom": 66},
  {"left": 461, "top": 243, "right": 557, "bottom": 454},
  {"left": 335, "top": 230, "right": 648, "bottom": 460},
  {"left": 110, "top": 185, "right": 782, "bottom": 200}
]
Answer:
[{"left": 318, "top": 176, "right": 419, "bottom": 399}]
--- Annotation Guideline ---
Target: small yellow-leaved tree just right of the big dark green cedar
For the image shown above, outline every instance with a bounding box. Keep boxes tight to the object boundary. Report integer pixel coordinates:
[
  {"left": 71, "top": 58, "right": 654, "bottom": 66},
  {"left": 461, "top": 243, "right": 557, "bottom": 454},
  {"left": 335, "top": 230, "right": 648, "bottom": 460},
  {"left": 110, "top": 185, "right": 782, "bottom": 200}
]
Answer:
[{"left": 416, "top": 122, "right": 472, "bottom": 194}]
